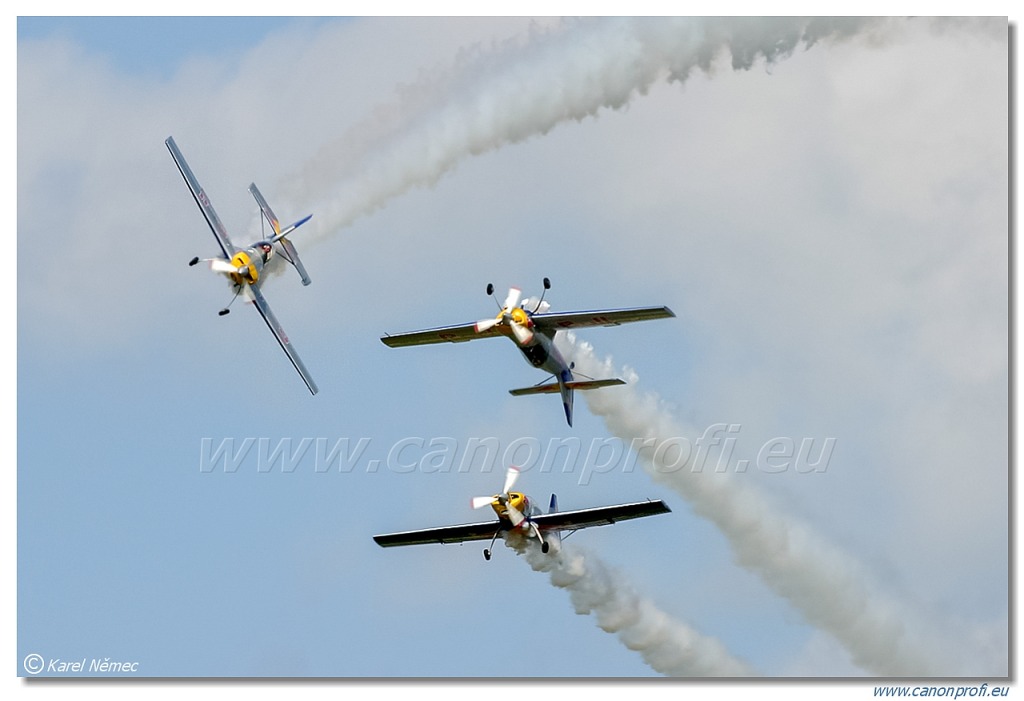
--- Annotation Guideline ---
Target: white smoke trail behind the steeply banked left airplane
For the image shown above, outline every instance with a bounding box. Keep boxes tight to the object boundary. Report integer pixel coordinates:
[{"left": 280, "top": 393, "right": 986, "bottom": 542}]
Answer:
[{"left": 289, "top": 17, "right": 893, "bottom": 235}]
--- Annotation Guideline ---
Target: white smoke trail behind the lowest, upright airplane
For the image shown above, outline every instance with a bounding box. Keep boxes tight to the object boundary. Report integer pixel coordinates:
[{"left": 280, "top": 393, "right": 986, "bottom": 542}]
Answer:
[{"left": 506, "top": 537, "right": 754, "bottom": 677}]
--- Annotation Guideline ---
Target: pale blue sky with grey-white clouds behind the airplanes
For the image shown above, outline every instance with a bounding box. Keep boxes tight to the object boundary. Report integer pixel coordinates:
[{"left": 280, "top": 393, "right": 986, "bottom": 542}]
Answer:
[{"left": 16, "top": 10, "right": 1009, "bottom": 695}]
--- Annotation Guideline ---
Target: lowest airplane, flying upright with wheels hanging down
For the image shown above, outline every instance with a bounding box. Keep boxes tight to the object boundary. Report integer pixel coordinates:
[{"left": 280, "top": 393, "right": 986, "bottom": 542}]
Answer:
[{"left": 374, "top": 468, "right": 672, "bottom": 560}]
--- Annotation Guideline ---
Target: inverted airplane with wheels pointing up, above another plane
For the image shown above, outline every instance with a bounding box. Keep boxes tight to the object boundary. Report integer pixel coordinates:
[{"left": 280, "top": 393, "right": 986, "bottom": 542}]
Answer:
[{"left": 381, "top": 277, "right": 675, "bottom": 426}]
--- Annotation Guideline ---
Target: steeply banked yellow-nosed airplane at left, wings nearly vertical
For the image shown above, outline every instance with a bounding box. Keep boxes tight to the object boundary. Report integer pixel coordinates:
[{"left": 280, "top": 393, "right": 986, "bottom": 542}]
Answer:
[{"left": 165, "top": 136, "right": 316, "bottom": 394}]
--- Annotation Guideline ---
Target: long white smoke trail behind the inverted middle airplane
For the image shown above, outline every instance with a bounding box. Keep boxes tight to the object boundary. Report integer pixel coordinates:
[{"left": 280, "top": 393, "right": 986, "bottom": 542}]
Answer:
[{"left": 565, "top": 334, "right": 991, "bottom": 676}]
